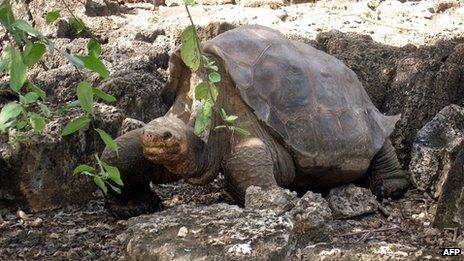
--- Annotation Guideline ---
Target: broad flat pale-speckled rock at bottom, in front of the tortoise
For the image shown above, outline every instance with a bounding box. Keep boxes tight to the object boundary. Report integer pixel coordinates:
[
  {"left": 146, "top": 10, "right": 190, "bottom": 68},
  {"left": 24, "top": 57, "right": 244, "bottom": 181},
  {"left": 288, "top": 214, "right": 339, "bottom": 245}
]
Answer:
[{"left": 125, "top": 204, "right": 294, "bottom": 260}]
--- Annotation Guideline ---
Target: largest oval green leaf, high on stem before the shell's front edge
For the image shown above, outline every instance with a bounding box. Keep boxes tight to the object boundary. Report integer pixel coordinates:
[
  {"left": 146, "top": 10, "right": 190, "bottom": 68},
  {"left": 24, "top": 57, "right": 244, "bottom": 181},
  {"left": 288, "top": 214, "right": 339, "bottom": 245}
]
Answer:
[{"left": 180, "top": 25, "right": 201, "bottom": 71}]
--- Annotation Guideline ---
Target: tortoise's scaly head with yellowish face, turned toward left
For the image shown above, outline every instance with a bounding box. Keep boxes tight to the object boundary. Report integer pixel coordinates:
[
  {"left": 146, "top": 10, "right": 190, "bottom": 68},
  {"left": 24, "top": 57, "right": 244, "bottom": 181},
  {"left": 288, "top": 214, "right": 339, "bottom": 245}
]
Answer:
[{"left": 141, "top": 116, "right": 205, "bottom": 178}]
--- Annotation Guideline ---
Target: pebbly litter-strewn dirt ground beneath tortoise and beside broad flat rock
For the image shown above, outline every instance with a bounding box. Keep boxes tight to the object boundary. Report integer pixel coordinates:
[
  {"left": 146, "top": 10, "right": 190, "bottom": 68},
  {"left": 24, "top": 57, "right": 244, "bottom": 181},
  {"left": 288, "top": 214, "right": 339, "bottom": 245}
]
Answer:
[{"left": 0, "top": 180, "right": 464, "bottom": 260}]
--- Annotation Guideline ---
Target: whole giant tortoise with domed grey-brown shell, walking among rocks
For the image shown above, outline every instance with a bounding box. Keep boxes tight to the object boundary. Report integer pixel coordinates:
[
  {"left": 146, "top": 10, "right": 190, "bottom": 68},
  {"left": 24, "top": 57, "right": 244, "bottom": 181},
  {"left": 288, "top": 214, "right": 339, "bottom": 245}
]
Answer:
[{"left": 103, "top": 25, "right": 409, "bottom": 216}]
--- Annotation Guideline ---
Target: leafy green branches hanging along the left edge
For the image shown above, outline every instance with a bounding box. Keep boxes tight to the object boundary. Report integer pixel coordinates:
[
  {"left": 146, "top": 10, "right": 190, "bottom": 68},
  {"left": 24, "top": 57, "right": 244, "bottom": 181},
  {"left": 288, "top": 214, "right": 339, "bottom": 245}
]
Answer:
[{"left": 0, "top": 0, "right": 123, "bottom": 194}]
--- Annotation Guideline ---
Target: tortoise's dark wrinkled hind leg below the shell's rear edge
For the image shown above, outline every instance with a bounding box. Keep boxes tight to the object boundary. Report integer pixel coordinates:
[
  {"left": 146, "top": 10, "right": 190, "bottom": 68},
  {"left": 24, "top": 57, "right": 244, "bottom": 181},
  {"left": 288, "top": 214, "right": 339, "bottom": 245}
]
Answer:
[{"left": 368, "top": 139, "right": 410, "bottom": 199}]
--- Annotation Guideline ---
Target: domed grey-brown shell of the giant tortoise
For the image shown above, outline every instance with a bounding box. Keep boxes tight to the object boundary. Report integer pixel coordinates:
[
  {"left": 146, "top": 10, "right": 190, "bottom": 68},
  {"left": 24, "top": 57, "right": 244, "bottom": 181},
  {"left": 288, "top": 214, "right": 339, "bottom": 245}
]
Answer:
[{"left": 204, "top": 25, "right": 399, "bottom": 173}]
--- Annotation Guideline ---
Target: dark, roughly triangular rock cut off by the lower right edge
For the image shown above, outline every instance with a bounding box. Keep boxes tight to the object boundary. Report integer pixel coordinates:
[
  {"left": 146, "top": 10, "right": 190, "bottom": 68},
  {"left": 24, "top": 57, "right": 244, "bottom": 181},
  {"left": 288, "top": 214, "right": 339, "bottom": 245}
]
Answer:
[{"left": 433, "top": 148, "right": 464, "bottom": 228}]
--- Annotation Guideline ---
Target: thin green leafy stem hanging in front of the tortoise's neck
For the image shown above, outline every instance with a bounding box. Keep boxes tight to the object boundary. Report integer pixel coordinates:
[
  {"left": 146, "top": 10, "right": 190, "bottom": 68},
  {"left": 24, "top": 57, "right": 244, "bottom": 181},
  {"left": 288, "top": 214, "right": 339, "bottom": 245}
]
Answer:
[{"left": 180, "top": 0, "right": 250, "bottom": 136}]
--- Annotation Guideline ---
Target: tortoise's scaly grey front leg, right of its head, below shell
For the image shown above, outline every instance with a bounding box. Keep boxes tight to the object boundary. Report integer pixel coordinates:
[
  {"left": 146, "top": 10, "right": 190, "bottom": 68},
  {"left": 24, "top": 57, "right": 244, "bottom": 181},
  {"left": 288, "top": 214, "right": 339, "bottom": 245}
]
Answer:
[{"left": 224, "top": 137, "right": 277, "bottom": 205}]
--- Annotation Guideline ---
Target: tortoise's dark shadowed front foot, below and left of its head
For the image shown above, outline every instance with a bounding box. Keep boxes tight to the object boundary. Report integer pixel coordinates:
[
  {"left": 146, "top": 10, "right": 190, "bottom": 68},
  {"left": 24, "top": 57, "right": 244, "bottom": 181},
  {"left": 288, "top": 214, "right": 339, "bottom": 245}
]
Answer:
[{"left": 105, "top": 193, "right": 163, "bottom": 219}]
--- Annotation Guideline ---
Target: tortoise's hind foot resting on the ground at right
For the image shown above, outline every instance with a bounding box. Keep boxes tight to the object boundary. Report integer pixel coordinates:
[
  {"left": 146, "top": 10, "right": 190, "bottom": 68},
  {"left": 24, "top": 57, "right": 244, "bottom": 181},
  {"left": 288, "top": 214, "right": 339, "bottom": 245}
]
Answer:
[{"left": 371, "top": 171, "right": 409, "bottom": 200}]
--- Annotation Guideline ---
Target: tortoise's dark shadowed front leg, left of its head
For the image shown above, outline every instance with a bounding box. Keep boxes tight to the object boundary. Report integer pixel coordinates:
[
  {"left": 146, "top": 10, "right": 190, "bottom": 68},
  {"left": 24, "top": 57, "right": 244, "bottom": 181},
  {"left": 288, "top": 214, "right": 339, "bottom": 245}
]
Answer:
[{"left": 101, "top": 128, "right": 178, "bottom": 219}]
